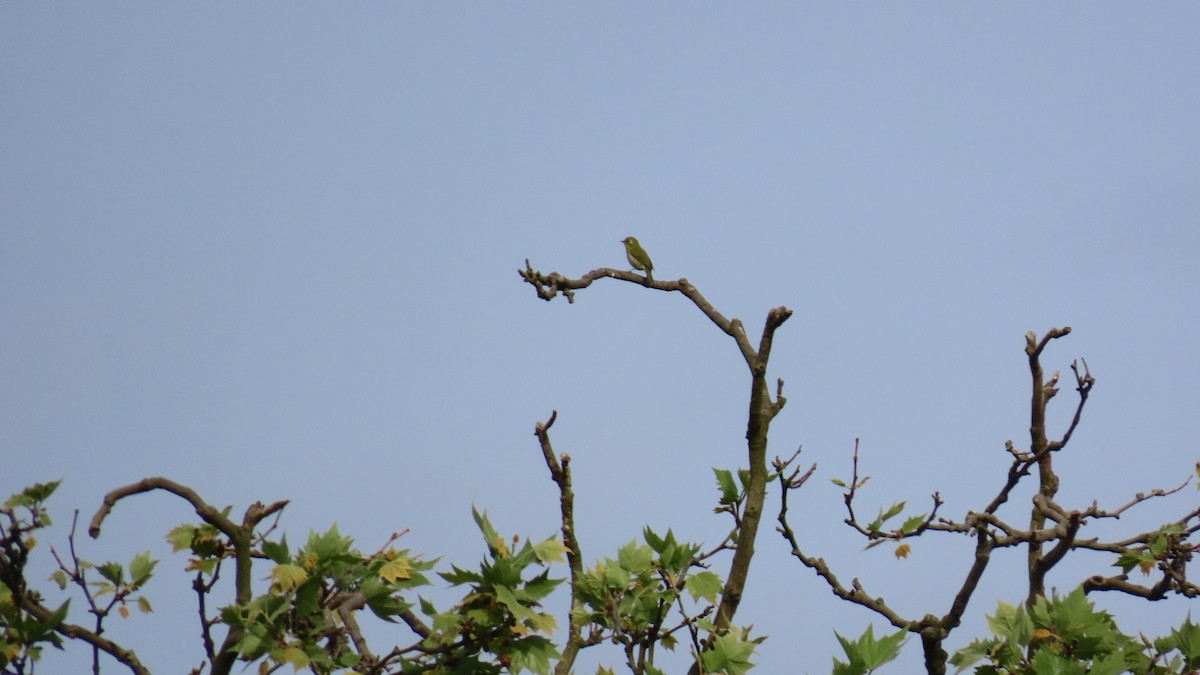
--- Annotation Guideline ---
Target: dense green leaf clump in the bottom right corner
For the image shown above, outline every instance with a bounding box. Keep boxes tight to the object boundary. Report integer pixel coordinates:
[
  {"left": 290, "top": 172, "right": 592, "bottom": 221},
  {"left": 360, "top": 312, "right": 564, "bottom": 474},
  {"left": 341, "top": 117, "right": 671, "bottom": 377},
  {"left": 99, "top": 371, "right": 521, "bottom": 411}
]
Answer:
[{"left": 950, "top": 589, "right": 1200, "bottom": 675}]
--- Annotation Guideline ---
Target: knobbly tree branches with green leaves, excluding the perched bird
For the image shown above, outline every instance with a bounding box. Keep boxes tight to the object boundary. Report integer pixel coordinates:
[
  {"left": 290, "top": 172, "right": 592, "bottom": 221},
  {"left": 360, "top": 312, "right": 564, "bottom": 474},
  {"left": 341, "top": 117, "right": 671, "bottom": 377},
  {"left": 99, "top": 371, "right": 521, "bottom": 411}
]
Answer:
[{"left": 0, "top": 294, "right": 1200, "bottom": 675}]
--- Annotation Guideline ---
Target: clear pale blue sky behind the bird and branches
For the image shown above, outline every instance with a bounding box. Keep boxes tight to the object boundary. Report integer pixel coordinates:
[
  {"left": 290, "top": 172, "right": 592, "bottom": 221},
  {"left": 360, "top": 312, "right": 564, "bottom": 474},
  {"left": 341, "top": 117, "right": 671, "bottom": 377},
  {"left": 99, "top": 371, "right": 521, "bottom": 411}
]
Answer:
[{"left": 0, "top": 2, "right": 1200, "bottom": 673}]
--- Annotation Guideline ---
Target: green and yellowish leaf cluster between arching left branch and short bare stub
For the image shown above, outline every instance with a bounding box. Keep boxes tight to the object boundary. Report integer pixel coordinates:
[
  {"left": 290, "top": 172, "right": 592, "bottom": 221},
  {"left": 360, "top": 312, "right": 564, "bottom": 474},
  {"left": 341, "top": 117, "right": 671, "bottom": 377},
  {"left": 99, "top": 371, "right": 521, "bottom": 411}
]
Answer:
[{"left": 168, "top": 502, "right": 573, "bottom": 674}]
